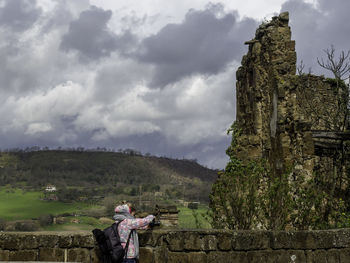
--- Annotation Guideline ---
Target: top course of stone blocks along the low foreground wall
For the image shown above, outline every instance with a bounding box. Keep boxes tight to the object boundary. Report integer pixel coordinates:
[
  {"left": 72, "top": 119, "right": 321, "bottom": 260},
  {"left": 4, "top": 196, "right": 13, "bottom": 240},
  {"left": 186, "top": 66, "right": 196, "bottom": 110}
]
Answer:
[{"left": 0, "top": 228, "right": 350, "bottom": 251}]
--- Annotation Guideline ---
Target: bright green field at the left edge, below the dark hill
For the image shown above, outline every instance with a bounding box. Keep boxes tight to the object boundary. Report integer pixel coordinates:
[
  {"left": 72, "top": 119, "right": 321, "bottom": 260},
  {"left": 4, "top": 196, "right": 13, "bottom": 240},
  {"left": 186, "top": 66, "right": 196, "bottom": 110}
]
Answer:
[{"left": 0, "top": 188, "right": 89, "bottom": 220}]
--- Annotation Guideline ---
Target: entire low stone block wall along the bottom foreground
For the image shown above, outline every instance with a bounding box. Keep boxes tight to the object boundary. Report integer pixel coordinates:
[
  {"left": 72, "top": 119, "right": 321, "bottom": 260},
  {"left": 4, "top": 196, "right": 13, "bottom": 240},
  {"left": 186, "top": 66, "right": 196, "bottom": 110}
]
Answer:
[{"left": 0, "top": 229, "right": 350, "bottom": 263}]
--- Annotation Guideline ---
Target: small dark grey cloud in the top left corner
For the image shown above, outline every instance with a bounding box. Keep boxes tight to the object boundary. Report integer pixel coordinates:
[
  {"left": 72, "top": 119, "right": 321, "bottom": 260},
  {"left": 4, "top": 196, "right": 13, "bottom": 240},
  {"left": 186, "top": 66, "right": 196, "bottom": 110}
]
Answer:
[{"left": 0, "top": 0, "right": 41, "bottom": 31}]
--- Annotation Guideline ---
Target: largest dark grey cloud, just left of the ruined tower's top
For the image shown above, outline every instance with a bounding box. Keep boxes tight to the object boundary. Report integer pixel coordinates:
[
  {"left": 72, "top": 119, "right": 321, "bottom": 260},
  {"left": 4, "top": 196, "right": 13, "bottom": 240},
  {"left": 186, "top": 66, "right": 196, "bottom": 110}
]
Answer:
[{"left": 137, "top": 5, "right": 257, "bottom": 86}]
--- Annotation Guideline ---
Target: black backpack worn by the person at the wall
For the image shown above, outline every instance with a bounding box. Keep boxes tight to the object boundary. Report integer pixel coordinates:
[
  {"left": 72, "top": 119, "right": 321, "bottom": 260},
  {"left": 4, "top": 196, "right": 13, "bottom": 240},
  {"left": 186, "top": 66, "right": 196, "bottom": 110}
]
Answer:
[{"left": 92, "top": 222, "right": 134, "bottom": 263}]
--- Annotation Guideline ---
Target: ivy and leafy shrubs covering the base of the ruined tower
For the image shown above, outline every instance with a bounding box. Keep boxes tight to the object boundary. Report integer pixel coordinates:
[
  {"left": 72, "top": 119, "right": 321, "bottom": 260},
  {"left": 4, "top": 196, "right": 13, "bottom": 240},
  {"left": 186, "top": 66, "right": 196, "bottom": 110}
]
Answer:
[{"left": 210, "top": 123, "right": 348, "bottom": 230}]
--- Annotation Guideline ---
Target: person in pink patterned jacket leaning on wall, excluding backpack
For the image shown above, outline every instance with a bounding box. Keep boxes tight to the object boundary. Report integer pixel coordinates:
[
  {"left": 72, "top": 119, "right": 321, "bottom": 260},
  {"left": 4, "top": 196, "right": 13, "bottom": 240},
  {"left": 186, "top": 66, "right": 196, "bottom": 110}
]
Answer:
[{"left": 113, "top": 204, "right": 154, "bottom": 263}]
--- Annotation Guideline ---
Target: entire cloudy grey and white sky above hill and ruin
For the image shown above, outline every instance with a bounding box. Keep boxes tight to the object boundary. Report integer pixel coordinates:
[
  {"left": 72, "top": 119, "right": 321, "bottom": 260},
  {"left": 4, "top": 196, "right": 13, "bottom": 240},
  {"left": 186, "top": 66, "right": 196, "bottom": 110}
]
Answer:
[{"left": 0, "top": 0, "right": 350, "bottom": 168}]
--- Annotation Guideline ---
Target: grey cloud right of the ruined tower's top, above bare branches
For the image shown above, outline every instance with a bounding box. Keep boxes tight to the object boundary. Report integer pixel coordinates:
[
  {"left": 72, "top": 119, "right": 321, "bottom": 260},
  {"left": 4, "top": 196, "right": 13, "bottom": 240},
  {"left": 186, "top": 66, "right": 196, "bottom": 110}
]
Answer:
[{"left": 281, "top": 0, "right": 350, "bottom": 74}]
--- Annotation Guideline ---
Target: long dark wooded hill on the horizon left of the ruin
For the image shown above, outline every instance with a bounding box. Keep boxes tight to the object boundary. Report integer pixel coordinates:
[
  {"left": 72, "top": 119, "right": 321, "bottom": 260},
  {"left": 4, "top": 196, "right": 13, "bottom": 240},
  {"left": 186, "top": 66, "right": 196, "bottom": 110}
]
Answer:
[{"left": 0, "top": 150, "right": 217, "bottom": 204}]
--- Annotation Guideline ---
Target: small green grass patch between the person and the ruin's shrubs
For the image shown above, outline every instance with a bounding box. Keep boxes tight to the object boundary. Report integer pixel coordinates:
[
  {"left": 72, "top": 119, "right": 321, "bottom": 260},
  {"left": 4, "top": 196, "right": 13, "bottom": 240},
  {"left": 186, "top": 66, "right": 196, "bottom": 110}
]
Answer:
[{"left": 178, "top": 206, "right": 211, "bottom": 229}]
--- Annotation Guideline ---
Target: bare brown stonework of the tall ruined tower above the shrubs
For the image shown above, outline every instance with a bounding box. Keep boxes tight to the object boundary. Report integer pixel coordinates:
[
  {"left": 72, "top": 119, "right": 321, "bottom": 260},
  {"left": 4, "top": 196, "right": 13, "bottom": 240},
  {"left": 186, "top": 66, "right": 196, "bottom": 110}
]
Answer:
[{"left": 236, "top": 12, "right": 344, "bottom": 180}]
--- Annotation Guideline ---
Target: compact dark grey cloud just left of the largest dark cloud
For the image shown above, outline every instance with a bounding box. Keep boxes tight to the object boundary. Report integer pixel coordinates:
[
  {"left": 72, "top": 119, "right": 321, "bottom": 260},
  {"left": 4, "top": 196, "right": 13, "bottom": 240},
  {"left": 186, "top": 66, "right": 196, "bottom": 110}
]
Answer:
[{"left": 60, "top": 6, "right": 136, "bottom": 59}]
